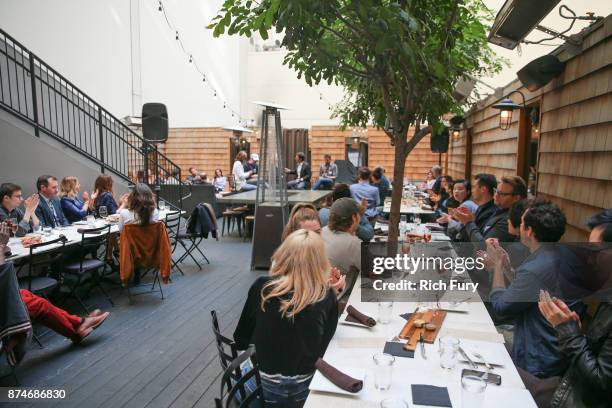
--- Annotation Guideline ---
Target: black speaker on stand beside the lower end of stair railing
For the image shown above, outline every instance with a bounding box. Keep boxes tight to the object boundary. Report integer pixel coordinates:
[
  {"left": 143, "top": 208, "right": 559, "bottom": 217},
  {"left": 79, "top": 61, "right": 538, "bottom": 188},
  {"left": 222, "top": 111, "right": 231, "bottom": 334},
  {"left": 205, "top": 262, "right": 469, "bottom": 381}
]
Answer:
[{"left": 142, "top": 102, "right": 168, "bottom": 203}]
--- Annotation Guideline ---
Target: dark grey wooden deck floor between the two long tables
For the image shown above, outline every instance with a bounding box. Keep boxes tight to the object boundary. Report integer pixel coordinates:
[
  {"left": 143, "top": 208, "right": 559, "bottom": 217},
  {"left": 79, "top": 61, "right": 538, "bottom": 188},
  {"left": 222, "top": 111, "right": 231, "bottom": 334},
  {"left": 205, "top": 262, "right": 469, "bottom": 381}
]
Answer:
[{"left": 6, "top": 237, "right": 265, "bottom": 408}]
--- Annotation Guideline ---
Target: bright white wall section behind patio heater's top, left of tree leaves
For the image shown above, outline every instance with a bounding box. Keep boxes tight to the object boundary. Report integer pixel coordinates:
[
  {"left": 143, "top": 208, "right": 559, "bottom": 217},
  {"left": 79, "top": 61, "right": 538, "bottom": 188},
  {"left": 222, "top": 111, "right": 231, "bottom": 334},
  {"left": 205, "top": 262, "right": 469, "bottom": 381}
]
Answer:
[{"left": 241, "top": 51, "right": 343, "bottom": 128}]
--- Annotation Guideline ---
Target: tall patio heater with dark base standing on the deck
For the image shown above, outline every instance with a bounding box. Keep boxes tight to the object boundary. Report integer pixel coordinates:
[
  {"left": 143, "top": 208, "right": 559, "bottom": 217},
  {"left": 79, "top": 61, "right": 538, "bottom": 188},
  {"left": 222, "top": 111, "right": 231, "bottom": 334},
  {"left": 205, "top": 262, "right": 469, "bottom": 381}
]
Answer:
[{"left": 251, "top": 101, "right": 289, "bottom": 269}]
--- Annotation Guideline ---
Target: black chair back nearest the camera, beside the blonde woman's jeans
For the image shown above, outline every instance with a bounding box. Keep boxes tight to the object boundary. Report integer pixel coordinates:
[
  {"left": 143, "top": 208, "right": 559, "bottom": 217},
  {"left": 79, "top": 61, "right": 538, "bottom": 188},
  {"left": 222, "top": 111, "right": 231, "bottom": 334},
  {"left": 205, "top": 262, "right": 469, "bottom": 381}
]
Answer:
[{"left": 215, "top": 345, "right": 265, "bottom": 408}]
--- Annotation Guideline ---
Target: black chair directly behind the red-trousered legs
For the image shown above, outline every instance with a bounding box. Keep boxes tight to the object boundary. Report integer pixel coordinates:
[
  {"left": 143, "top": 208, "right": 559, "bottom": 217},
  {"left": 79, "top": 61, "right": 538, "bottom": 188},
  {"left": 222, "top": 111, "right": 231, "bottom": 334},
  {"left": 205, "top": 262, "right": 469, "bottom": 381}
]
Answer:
[{"left": 17, "top": 235, "right": 68, "bottom": 348}]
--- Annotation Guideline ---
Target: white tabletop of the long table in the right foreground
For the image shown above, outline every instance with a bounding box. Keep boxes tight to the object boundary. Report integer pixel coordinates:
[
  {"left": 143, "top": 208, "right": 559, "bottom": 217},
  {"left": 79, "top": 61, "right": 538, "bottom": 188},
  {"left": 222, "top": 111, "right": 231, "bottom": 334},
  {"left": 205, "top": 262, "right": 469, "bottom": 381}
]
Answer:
[{"left": 305, "top": 241, "right": 536, "bottom": 408}]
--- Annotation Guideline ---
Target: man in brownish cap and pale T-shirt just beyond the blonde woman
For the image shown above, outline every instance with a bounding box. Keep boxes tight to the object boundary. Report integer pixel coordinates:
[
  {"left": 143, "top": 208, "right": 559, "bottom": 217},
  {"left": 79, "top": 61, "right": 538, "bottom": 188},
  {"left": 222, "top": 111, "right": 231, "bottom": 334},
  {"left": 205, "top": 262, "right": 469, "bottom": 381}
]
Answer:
[{"left": 321, "top": 198, "right": 361, "bottom": 273}]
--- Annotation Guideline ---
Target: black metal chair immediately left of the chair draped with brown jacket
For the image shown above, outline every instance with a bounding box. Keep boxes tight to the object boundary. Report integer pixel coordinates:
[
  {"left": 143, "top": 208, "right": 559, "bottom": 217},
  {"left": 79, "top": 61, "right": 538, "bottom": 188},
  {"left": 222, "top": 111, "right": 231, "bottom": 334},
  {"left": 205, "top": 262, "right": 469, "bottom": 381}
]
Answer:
[{"left": 64, "top": 225, "right": 114, "bottom": 314}]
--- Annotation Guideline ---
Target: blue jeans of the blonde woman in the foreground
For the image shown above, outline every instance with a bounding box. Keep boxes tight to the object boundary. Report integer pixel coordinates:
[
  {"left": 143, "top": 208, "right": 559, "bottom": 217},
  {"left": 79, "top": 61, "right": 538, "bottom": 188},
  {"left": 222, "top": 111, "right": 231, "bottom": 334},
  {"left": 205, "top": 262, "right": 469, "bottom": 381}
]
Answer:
[{"left": 261, "top": 373, "right": 312, "bottom": 408}]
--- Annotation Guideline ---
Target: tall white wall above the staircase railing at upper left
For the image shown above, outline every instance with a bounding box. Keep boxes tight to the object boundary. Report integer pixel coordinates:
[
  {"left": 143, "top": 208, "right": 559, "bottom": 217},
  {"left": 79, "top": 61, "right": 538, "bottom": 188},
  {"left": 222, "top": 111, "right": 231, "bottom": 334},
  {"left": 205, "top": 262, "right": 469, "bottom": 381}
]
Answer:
[{"left": 0, "top": 0, "right": 240, "bottom": 127}]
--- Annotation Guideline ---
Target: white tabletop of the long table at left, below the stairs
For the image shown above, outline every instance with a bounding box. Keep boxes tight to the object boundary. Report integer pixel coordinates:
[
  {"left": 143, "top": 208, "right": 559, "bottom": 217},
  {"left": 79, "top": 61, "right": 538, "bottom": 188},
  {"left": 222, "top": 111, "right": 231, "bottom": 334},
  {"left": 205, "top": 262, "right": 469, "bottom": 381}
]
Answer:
[{"left": 7, "top": 210, "right": 185, "bottom": 261}]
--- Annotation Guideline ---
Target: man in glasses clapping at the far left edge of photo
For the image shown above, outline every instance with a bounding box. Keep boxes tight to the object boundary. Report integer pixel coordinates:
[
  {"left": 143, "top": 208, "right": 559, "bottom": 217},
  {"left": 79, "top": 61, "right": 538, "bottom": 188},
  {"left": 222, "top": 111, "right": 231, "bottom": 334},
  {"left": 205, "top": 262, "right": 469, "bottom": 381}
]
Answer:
[{"left": 0, "top": 183, "right": 39, "bottom": 237}]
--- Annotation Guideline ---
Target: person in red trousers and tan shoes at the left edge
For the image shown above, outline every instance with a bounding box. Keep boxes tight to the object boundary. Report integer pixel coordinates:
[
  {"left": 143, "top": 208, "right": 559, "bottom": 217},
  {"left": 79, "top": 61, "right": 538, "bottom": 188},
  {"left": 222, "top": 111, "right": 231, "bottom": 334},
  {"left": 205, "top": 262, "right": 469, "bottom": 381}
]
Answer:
[{"left": 0, "top": 223, "right": 110, "bottom": 344}]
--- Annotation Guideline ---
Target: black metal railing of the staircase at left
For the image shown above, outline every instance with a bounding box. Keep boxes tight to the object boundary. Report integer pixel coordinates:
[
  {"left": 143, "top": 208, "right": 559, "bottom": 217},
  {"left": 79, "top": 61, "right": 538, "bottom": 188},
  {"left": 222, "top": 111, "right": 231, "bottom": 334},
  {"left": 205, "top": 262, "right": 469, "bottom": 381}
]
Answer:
[{"left": 0, "top": 29, "right": 183, "bottom": 208}]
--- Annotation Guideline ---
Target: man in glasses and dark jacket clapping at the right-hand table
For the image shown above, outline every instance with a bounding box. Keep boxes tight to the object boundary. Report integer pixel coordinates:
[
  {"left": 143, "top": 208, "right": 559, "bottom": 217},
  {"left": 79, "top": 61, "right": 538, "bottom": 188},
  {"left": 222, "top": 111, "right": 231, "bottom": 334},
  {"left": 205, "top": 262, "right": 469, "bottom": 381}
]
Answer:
[{"left": 453, "top": 176, "right": 527, "bottom": 245}]
